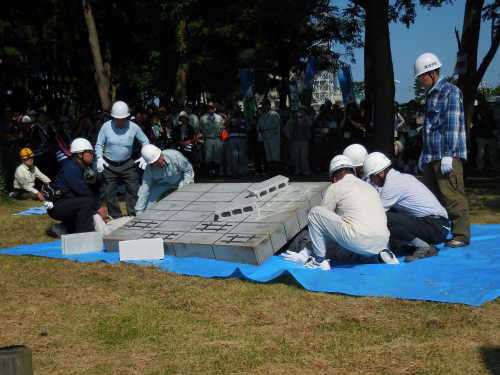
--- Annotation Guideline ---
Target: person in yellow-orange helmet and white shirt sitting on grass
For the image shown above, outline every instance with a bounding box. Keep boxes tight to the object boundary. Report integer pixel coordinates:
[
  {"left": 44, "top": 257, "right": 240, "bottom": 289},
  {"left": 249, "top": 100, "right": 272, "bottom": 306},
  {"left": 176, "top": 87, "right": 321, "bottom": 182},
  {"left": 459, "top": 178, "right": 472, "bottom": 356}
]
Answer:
[{"left": 11, "top": 147, "right": 50, "bottom": 201}]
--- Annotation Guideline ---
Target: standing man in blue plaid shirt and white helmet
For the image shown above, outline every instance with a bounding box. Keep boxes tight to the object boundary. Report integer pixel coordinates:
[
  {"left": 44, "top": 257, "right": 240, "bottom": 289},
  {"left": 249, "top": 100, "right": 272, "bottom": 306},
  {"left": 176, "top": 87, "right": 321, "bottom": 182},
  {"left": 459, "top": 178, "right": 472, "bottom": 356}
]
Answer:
[{"left": 415, "top": 53, "right": 470, "bottom": 247}]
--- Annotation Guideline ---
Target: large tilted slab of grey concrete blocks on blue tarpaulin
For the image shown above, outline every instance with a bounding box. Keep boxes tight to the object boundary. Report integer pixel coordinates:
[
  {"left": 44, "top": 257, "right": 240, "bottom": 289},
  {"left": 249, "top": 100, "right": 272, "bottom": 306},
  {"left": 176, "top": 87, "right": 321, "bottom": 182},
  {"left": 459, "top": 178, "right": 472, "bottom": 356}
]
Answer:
[{"left": 104, "top": 176, "right": 329, "bottom": 264}]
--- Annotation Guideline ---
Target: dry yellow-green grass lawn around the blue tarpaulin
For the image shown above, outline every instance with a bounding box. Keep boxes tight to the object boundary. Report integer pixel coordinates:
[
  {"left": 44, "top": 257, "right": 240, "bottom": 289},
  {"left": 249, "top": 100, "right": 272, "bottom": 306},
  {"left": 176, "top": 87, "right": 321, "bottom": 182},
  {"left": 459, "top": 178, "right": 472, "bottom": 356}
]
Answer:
[{"left": 0, "top": 188, "right": 500, "bottom": 375}]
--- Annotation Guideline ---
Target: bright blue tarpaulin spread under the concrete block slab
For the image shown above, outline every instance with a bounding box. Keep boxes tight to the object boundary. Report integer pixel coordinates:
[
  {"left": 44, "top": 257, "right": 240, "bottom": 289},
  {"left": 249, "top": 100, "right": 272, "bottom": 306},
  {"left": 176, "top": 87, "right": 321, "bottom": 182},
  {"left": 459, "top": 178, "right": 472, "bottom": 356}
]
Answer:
[{"left": 0, "top": 224, "right": 500, "bottom": 306}]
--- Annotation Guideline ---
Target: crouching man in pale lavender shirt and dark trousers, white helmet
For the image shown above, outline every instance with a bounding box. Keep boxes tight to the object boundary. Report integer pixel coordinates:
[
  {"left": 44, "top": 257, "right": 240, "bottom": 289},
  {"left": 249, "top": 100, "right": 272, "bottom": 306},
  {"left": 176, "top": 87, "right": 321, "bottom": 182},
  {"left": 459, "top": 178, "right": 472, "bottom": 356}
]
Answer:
[{"left": 363, "top": 152, "right": 450, "bottom": 262}]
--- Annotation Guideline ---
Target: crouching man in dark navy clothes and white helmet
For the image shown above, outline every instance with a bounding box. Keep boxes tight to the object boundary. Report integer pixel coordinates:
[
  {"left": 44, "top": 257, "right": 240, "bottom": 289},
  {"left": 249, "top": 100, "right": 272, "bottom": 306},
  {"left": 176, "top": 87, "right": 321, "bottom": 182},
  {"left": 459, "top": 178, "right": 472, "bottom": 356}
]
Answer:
[{"left": 47, "top": 138, "right": 106, "bottom": 236}]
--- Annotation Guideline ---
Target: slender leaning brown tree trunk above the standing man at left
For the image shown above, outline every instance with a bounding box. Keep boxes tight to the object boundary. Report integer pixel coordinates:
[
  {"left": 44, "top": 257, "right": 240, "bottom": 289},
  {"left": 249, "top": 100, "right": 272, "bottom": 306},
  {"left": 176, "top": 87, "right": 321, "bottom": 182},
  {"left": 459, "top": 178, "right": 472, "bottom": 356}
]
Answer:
[{"left": 82, "top": 0, "right": 111, "bottom": 111}]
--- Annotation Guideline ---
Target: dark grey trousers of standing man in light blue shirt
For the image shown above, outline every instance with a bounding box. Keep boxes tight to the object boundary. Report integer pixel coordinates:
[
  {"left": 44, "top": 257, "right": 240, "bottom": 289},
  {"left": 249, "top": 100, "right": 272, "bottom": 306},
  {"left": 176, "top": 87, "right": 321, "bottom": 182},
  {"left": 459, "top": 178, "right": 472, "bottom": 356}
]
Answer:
[{"left": 102, "top": 159, "right": 140, "bottom": 219}]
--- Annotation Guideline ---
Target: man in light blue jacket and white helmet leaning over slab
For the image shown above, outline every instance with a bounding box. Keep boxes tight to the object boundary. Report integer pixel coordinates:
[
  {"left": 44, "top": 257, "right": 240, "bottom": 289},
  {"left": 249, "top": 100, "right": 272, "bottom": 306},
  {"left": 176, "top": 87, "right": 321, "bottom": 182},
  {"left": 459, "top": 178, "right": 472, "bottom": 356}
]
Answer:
[{"left": 135, "top": 145, "right": 194, "bottom": 214}]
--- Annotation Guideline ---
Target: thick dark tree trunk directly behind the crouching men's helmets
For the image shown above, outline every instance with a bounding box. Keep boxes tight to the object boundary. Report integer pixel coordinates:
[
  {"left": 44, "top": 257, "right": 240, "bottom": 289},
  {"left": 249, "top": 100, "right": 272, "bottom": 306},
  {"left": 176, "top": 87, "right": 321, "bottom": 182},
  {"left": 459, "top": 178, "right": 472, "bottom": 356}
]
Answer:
[{"left": 365, "top": 0, "right": 394, "bottom": 157}]
